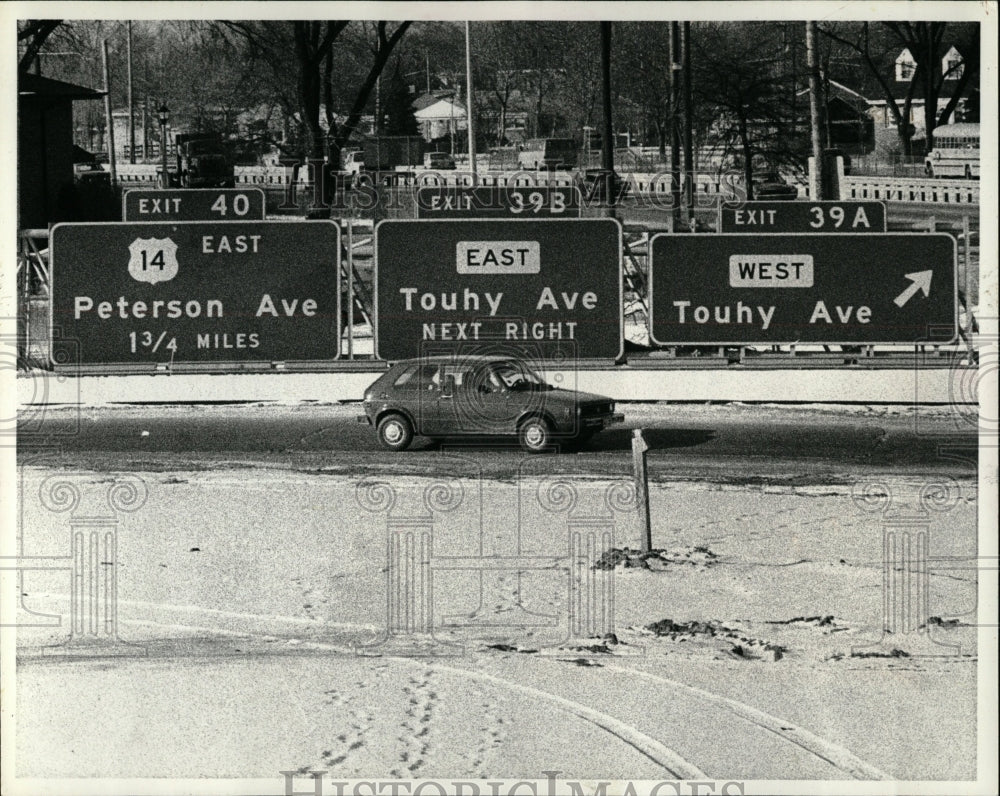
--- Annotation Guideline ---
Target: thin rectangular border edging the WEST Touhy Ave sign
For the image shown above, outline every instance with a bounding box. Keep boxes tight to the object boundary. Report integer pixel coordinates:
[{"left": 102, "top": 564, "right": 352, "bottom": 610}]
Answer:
[{"left": 647, "top": 232, "right": 959, "bottom": 347}]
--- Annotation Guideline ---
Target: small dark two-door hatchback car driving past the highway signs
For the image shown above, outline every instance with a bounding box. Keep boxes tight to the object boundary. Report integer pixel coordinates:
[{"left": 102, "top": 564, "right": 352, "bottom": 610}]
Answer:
[{"left": 358, "top": 356, "right": 625, "bottom": 453}]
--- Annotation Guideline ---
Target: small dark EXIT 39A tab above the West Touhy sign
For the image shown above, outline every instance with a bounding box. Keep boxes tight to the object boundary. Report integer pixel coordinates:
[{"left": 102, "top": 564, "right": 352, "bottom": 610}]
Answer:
[{"left": 719, "top": 201, "right": 887, "bottom": 234}]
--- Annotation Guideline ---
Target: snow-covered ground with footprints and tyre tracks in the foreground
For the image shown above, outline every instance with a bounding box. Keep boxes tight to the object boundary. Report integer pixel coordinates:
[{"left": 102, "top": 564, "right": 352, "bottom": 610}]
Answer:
[{"left": 16, "top": 466, "right": 978, "bottom": 788}]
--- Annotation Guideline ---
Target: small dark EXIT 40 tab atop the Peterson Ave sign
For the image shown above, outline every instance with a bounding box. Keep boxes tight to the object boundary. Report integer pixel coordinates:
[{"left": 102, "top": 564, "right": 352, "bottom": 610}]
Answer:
[{"left": 122, "top": 188, "right": 265, "bottom": 221}]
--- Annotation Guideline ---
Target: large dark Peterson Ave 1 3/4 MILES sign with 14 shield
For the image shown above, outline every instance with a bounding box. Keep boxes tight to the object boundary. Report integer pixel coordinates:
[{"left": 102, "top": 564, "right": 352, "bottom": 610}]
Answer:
[{"left": 51, "top": 221, "right": 340, "bottom": 366}]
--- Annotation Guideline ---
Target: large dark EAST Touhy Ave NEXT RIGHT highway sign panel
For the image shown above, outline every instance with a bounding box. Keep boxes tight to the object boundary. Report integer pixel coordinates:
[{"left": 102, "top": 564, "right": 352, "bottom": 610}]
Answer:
[{"left": 375, "top": 219, "right": 623, "bottom": 360}]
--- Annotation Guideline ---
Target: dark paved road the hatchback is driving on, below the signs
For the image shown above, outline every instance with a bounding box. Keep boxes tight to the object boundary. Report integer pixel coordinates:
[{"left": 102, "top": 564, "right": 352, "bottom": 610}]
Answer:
[{"left": 19, "top": 404, "right": 975, "bottom": 482}]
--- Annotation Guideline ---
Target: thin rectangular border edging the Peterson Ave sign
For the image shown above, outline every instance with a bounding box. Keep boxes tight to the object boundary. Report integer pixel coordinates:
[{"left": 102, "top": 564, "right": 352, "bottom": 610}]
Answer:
[{"left": 48, "top": 221, "right": 344, "bottom": 373}]
